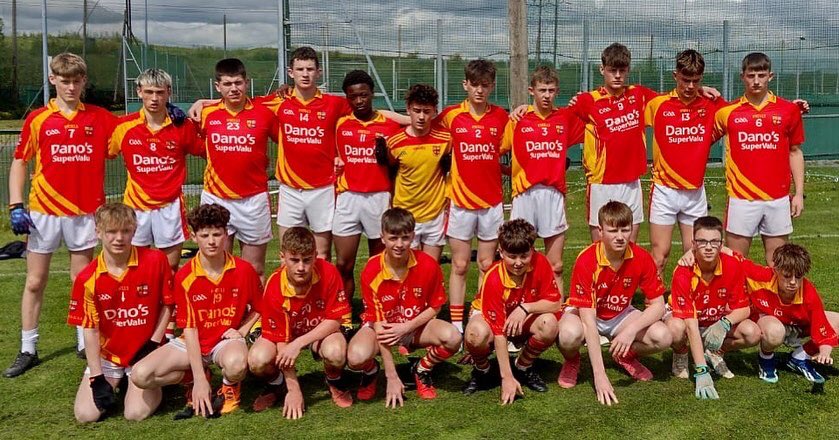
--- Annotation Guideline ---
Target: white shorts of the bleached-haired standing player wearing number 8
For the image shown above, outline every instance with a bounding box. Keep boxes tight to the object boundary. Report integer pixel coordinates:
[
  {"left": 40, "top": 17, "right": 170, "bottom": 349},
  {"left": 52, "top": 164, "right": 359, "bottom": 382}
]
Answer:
[{"left": 131, "top": 197, "right": 189, "bottom": 249}]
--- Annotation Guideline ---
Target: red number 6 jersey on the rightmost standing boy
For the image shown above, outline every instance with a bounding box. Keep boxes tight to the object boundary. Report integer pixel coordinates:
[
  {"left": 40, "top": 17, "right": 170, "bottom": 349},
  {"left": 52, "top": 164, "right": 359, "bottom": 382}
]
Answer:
[{"left": 714, "top": 93, "right": 804, "bottom": 200}]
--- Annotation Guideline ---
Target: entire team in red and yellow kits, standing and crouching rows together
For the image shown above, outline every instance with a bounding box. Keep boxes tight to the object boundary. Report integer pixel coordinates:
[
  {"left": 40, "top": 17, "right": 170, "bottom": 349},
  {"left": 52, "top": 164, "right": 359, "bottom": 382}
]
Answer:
[{"left": 5, "top": 44, "right": 837, "bottom": 421}]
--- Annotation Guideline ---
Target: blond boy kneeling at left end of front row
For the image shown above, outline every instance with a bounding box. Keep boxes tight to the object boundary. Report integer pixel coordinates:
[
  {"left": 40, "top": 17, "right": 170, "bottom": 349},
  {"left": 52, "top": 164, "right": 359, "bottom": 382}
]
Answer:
[{"left": 70, "top": 203, "right": 174, "bottom": 423}]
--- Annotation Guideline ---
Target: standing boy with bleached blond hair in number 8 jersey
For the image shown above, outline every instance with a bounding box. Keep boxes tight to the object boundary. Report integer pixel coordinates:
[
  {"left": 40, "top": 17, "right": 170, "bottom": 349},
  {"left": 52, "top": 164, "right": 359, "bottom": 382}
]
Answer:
[{"left": 109, "top": 69, "right": 206, "bottom": 271}]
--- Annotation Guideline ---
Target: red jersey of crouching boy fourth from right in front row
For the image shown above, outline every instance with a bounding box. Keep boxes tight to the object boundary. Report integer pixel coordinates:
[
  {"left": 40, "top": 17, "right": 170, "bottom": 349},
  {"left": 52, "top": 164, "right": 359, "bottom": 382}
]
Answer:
[{"left": 472, "top": 251, "right": 562, "bottom": 336}]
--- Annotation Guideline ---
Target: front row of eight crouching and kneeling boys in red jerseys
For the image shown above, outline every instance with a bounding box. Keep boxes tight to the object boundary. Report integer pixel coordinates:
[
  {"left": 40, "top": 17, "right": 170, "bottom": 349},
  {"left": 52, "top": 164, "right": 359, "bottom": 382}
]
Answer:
[{"left": 68, "top": 202, "right": 839, "bottom": 422}]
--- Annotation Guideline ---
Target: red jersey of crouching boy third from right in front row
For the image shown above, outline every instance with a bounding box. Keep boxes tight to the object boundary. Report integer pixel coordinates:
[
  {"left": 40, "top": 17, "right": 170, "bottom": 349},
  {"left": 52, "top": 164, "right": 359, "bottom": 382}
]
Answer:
[{"left": 568, "top": 241, "right": 664, "bottom": 320}]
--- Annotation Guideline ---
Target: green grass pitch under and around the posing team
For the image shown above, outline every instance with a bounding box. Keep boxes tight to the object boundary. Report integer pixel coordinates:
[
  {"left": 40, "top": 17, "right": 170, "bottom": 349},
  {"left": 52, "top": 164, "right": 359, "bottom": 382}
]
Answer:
[{"left": 0, "top": 164, "right": 839, "bottom": 439}]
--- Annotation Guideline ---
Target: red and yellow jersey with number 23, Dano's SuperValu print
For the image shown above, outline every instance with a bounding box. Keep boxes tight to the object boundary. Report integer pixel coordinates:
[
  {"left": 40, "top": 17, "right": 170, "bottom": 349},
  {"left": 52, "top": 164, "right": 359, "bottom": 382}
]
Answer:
[{"left": 201, "top": 100, "right": 277, "bottom": 199}]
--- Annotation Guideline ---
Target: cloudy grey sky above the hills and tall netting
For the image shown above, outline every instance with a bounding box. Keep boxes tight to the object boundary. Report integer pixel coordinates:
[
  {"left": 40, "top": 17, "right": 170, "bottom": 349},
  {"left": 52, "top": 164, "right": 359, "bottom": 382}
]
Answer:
[{"left": 0, "top": 0, "right": 839, "bottom": 59}]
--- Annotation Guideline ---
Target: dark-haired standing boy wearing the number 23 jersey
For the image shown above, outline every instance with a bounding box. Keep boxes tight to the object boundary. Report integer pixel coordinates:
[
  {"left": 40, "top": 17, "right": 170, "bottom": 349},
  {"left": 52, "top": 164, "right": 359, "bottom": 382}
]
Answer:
[{"left": 196, "top": 58, "right": 278, "bottom": 277}]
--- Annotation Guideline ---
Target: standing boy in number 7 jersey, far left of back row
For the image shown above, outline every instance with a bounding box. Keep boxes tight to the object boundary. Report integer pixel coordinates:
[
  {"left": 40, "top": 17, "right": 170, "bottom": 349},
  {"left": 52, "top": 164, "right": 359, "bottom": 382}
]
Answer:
[{"left": 3, "top": 53, "right": 117, "bottom": 377}]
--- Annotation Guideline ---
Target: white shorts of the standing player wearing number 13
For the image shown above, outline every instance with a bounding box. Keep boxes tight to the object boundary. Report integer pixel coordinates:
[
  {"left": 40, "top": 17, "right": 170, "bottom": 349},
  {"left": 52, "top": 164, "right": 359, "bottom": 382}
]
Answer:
[{"left": 650, "top": 183, "right": 708, "bottom": 226}]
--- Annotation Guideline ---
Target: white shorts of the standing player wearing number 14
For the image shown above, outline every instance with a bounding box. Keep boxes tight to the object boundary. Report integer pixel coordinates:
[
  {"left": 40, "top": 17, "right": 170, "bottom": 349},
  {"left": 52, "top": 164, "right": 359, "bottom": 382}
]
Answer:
[{"left": 277, "top": 185, "right": 336, "bottom": 233}]
